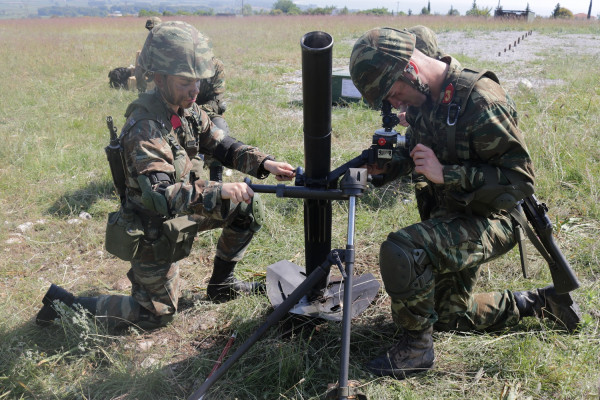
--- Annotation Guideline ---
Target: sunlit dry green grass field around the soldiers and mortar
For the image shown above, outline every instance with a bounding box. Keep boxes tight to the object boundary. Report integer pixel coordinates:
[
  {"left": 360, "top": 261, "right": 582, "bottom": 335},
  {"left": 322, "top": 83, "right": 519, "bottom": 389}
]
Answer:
[{"left": 0, "top": 16, "right": 600, "bottom": 400}]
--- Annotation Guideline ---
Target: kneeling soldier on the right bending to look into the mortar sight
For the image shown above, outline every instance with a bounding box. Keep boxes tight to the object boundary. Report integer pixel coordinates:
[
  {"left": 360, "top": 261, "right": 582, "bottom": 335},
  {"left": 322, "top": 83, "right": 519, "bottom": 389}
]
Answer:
[{"left": 350, "top": 28, "right": 581, "bottom": 379}]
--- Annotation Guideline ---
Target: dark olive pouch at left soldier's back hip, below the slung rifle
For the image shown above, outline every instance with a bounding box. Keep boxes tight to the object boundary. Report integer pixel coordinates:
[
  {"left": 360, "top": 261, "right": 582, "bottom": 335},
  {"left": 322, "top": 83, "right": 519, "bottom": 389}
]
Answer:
[{"left": 105, "top": 208, "right": 144, "bottom": 261}]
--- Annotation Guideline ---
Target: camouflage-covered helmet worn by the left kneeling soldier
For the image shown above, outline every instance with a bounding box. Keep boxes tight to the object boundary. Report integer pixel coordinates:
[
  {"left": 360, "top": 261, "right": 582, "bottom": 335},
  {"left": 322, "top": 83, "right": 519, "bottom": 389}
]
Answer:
[{"left": 139, "top": 21, "right": 215, "bottom": 80}]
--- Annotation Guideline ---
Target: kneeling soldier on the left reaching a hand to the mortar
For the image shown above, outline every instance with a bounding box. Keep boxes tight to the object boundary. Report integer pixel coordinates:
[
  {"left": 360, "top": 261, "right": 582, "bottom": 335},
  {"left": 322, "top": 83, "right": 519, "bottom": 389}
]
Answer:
[{"left": 36, "top": 21, "right": 294, "bottom": 328}]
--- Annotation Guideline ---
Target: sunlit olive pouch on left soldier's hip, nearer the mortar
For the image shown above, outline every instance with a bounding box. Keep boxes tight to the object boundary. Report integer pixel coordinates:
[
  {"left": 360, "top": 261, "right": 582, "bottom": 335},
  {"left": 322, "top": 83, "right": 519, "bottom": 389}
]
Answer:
[{"left": 152, "top": 216, "right": 198, "bottom": 263}]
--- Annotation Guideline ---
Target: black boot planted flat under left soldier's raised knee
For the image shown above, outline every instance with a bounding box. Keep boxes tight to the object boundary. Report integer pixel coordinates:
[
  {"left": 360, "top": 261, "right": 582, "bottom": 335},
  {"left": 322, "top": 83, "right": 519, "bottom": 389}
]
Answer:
[{"left": 206, "top": 257, "right": 264, "bottom": 301}]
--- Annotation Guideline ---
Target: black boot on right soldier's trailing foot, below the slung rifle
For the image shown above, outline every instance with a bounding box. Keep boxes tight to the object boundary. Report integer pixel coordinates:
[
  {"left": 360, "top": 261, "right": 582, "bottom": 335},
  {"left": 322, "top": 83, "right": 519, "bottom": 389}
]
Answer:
[{"left": 513, "top": 285, "right": 581, "bottom": 332}]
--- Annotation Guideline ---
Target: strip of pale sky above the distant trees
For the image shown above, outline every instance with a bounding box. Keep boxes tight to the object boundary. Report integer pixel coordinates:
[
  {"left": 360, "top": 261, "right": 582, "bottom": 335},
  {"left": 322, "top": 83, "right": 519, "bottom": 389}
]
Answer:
[{"left": 294, "top": 0, "right": 600, "bottom": 17}]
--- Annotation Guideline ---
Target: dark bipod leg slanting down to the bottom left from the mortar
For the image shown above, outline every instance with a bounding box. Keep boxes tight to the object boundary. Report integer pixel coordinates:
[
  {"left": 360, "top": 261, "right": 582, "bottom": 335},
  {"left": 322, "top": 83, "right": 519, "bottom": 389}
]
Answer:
[{"left": 188, "top": 250, "right": 338, "bottom": 400}]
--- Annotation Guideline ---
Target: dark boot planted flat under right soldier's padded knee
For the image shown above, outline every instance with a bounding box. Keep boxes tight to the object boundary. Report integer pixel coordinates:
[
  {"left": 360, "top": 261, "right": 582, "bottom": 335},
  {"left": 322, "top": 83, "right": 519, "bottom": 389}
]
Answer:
[{"left": 367, "top": 326, "right": 435, "bottom": 379}]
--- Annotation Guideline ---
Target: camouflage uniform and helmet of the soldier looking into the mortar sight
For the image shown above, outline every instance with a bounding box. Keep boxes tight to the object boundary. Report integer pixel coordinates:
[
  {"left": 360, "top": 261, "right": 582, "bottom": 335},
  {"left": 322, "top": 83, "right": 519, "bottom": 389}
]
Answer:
[{"left": 351, "top": 29, "right": 534, "bottom": 331}]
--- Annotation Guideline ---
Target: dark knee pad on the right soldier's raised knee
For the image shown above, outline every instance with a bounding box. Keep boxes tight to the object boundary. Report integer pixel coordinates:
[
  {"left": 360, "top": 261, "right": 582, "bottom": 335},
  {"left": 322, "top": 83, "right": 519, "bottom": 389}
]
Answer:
[{"left": 379, "top": 238, "right": 433, "bottom": 299}]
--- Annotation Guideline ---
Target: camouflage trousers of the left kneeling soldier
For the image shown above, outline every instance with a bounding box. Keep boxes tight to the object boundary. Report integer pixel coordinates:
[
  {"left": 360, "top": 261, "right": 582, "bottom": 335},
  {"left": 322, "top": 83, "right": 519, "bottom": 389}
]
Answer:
[{"left": 96, "top": 203, "right": 254, "bottom": 327}]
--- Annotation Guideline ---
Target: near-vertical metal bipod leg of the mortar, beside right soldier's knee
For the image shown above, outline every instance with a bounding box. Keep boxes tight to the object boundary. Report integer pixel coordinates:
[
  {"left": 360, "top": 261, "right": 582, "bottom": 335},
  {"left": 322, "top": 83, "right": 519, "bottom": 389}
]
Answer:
[{"left": 338, "top": 196, "right": 356, "bottom": 400}]
